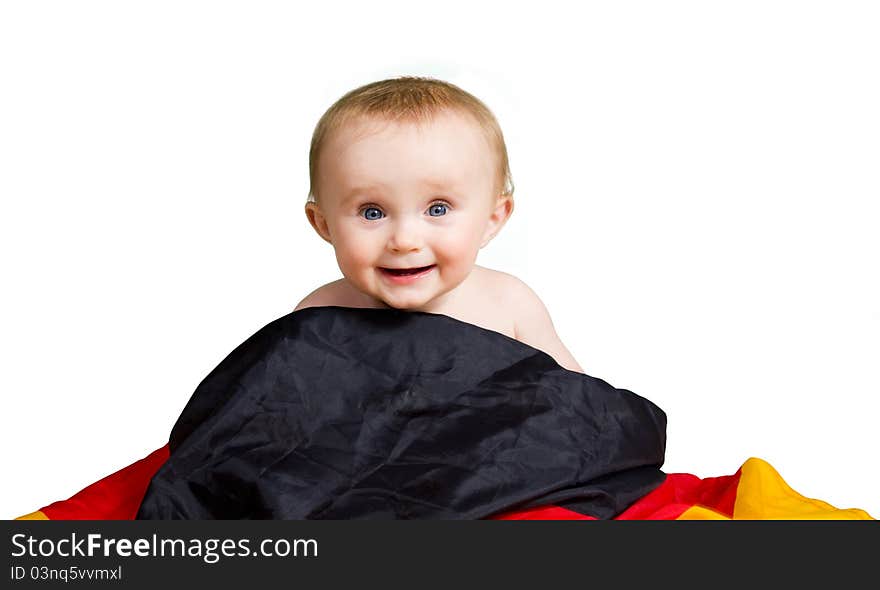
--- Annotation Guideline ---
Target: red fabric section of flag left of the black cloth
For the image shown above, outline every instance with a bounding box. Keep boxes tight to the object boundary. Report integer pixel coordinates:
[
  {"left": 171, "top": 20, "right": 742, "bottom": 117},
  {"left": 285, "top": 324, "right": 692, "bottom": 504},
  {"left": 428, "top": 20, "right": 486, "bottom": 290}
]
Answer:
[{"left": 40, "top": 445, "right": 168, "bottom": 520}]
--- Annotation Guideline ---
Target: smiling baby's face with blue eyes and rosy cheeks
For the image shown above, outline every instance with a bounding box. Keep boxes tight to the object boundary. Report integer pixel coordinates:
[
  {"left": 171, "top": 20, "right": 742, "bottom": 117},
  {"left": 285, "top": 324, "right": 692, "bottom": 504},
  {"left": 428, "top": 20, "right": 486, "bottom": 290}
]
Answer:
[{"left": 306, "top": 113, "right": 512, "bottom": 311}]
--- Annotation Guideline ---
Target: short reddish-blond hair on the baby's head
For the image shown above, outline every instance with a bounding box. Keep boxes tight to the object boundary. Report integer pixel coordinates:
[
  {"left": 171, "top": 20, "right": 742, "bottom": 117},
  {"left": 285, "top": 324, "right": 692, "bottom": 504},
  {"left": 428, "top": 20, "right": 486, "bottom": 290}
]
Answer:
[{"left": 309, "top": 76, "right": 513, "bottom": 201}]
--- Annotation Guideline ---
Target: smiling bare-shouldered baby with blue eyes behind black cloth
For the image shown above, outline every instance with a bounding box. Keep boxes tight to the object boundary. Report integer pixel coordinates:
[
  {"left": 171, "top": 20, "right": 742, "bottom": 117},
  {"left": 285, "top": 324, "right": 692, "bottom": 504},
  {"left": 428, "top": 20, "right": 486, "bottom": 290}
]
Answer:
[{"left": 296, "top": 77, "right": 583, "bottom": 373}]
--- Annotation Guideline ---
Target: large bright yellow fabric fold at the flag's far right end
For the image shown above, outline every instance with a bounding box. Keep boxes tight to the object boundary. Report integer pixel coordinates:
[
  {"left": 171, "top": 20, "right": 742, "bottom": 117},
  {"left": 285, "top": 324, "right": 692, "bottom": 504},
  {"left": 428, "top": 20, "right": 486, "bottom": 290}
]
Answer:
[{"left": 733, "top": 457, "right": 874, "bottom": 520}]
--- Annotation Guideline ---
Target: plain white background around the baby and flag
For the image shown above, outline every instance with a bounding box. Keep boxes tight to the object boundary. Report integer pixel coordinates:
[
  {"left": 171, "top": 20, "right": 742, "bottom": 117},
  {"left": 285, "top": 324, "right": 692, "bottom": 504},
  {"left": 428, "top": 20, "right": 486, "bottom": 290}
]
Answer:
[{"left": 0, "top": 0, "right": 880, "bottom": 518}]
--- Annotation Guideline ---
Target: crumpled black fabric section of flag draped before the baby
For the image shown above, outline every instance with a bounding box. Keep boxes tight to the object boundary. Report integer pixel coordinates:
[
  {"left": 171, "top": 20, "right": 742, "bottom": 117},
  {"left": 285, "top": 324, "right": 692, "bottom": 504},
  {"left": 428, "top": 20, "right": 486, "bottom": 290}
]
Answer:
[{"left": 137, "top": 307, "right": 666, "bottom": 519}]
